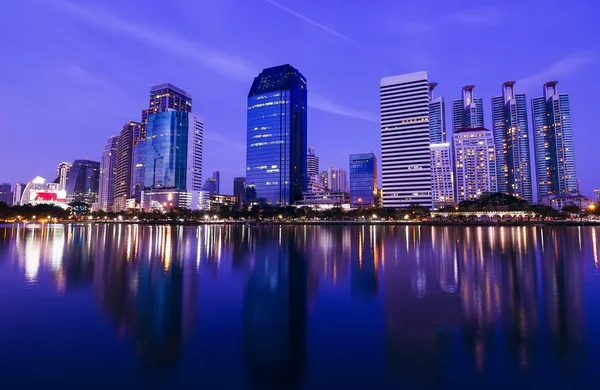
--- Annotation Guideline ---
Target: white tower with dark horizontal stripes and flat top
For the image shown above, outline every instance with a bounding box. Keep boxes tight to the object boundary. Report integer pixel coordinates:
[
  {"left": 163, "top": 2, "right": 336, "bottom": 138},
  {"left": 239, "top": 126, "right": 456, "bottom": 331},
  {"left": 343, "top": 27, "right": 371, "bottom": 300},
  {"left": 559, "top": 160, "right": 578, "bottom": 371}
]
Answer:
[{"left": 379, "top": 72, "right": 432, "bottom": 207}]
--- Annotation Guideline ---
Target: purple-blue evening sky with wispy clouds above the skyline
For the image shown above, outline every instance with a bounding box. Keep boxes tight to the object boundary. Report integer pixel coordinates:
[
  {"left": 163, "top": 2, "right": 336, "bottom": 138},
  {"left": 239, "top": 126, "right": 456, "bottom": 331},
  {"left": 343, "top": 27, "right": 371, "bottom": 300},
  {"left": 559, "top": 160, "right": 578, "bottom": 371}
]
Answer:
[{"left": 0, "top": 0, "right": 600, "bottom": 194}]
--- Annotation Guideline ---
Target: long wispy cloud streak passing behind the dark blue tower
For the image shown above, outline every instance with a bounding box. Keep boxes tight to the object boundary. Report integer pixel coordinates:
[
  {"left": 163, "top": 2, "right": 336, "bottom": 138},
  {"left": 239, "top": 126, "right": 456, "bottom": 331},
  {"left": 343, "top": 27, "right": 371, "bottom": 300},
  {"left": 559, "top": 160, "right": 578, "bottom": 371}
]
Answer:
[{"left": 50, "top": 0, "right": 373, "bottom": 121}]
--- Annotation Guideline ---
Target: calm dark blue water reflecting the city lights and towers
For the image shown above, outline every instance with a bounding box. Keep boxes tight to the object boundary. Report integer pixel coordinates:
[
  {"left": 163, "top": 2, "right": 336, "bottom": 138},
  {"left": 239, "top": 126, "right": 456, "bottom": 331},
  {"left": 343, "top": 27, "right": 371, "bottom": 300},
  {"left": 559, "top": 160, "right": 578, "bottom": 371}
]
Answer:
[{"left": 0, "top": 225, "right": 600, "bottom": 389}]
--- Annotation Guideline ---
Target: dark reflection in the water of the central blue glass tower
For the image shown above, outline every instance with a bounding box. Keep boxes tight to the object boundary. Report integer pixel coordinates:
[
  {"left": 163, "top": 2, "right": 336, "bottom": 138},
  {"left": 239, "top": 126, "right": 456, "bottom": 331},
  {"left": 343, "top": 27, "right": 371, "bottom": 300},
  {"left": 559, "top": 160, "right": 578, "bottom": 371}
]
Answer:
[{"left": 244, "top": 228, "right": 307, "bottom": 388}]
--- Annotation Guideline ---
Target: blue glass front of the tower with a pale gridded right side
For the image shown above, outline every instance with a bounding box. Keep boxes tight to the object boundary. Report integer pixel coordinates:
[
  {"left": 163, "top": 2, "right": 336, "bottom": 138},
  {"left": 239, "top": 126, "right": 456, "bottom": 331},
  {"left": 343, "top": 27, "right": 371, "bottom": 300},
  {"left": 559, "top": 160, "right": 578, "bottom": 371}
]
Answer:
[{"left": 139, "top": 111, "right": 189, "bottom": 190}]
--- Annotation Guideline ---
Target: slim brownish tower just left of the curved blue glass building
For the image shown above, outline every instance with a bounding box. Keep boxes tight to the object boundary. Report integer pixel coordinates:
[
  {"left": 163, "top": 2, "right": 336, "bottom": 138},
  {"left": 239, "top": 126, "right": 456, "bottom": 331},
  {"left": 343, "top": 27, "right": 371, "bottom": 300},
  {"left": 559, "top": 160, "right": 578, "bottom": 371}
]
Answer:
[{"left": 113, "top": 121, "right": 143, "bottom": 212}]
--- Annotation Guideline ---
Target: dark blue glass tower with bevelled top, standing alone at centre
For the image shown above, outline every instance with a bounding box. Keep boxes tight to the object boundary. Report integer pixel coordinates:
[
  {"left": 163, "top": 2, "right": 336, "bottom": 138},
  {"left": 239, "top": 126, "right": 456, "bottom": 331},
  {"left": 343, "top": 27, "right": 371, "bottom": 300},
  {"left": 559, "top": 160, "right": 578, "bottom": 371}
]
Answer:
[{"left": 246, "top": 64, "right": 307, "bottom": 204}]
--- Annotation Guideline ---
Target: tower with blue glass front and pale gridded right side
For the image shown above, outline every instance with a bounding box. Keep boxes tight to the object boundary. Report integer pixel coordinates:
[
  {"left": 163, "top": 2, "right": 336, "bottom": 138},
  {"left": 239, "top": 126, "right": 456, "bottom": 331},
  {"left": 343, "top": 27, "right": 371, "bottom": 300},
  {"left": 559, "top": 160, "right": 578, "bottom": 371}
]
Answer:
[{"left": 140, "top": 109, "right": 203, "bottom": 211}]
